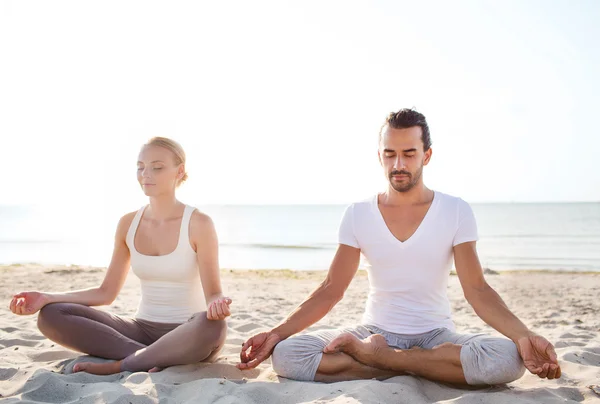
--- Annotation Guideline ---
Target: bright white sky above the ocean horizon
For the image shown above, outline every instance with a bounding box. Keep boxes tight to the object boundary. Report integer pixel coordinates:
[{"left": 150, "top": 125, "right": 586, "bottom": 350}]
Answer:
[{"left": 0, "top": 0, "right": 600, "bottom": 211}]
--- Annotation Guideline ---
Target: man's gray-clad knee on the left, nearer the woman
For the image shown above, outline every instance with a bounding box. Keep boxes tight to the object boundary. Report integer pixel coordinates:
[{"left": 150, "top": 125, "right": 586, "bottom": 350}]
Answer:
[{"left": 271, "top": 336, "right": 323, "bottom": 381}]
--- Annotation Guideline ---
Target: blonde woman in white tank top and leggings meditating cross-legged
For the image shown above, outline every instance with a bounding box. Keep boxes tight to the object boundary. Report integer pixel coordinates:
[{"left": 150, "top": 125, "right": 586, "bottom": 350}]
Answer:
[{"left": 10, "top": 137, "right": 231, "bottom": 374}]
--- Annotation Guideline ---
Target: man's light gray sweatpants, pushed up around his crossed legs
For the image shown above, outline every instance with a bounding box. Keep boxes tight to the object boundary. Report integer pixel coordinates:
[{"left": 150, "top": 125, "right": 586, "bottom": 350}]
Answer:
[{"left": 272, "top": 325, "right": 525, "bottom": 385}]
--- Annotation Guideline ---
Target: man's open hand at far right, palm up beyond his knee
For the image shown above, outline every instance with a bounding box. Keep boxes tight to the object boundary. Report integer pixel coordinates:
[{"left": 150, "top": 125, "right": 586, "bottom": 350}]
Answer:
[{"left": 517, "top": 334, "right": 561, "bottom": 379}]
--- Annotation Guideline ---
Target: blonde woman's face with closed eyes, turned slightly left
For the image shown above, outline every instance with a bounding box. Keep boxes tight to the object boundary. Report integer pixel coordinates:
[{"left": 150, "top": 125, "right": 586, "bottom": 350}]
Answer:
[{"left": 137, "top": 146, "right": 184, "bottom": 196}]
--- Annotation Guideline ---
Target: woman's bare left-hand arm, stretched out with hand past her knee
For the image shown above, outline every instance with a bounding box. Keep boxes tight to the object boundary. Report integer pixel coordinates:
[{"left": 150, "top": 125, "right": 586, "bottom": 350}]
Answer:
[{"left": 10, "top": 212, "right": 135, "bottom": 315}]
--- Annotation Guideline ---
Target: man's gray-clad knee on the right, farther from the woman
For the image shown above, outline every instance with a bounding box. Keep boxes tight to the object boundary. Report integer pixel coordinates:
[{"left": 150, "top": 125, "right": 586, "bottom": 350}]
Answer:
[{"left": 461, "top": 338, "right": 525, "bottom": 385}]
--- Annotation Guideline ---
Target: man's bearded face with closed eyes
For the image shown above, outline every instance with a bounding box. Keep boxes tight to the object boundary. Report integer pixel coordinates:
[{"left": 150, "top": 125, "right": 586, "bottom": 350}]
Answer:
[{"left": 379, "top": 126, "right": 431, "bottom": 192}]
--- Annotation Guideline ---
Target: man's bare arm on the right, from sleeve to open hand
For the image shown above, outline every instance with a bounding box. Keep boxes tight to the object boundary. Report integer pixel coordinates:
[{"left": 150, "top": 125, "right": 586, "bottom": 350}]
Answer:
[{"left": 454, "top": 241, "right": 561, "bottom": 379}]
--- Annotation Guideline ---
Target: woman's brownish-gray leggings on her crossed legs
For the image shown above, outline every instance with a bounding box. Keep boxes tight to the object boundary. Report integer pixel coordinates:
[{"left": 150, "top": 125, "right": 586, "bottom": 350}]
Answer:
[{"left": 38, "top": 303, "right": 227, "bottom": 372}]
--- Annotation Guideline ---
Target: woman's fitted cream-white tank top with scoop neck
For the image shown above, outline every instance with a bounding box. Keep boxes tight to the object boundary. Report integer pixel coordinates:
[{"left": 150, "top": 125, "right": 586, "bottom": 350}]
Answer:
[{"left": 126, "top": 205, "right": 206, "bottom": 323}]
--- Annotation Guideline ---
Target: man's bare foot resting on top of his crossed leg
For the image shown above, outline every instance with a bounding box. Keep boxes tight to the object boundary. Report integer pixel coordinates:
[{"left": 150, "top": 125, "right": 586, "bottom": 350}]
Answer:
[{"left": 323, "top": 333, "right": 390, "bottom": 367}]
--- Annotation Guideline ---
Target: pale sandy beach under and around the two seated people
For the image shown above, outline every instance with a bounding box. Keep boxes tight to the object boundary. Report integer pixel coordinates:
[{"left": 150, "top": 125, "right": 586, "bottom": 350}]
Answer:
[{"left": 0, "top": 264, "right": 600, "bottom": 404}]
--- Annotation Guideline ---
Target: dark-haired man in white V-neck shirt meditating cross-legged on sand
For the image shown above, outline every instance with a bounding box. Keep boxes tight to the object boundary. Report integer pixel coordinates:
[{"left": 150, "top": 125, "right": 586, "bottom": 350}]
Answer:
[{"left": 238, "top": 109, "right": 561, "bottom": 385}]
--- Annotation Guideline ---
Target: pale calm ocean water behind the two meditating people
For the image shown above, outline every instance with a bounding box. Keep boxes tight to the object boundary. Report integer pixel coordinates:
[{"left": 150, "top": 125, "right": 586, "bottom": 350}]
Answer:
[{"left": 0, "top": 203, "right": 600, "bottom": 272}]
